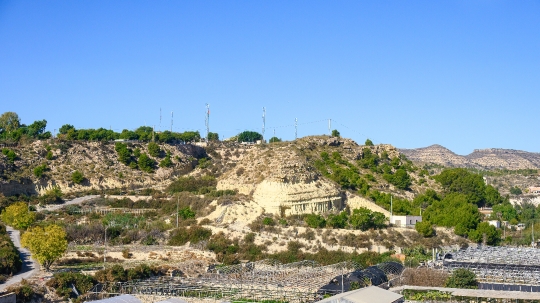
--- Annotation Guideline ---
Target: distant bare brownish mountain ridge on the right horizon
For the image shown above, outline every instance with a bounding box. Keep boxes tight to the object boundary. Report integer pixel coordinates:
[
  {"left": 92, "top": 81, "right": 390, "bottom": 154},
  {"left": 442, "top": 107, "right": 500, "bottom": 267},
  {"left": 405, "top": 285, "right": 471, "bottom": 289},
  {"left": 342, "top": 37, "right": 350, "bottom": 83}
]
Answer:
[{"left": 399, "top": 144, "right": 540, "bottom": 170}]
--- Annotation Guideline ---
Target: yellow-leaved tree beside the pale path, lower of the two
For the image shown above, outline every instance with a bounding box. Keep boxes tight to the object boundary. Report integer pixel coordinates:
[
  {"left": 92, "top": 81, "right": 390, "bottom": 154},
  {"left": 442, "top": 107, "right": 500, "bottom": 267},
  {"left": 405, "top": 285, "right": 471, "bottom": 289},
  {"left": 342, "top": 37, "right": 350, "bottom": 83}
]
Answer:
[{"left": 21, "top": 224, "right": 67, "bottom": 270}]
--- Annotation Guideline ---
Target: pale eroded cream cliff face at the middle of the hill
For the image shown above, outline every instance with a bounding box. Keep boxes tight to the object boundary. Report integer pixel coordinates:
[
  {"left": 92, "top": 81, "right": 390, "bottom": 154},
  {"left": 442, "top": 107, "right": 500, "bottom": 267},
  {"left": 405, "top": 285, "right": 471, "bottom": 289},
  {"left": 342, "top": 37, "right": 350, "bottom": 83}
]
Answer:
[{"left": 216, "top": 136, "right": 399, "bottom": 215}]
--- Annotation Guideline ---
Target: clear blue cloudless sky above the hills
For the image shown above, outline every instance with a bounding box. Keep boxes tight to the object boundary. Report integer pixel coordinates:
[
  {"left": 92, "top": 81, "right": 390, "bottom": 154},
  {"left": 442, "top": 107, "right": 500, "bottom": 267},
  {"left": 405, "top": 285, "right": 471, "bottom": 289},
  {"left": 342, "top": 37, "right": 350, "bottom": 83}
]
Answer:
[{"left": 0, "top": 0, "right": 540, "bottom": 154}]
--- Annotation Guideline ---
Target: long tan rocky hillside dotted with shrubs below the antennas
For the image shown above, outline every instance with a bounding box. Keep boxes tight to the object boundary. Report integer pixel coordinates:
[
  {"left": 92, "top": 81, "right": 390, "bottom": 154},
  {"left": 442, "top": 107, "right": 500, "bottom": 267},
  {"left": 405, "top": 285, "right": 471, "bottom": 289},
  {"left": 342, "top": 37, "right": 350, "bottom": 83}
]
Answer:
[{"left": 0, "top": 136, "right": 436, "bottom": 215}]
